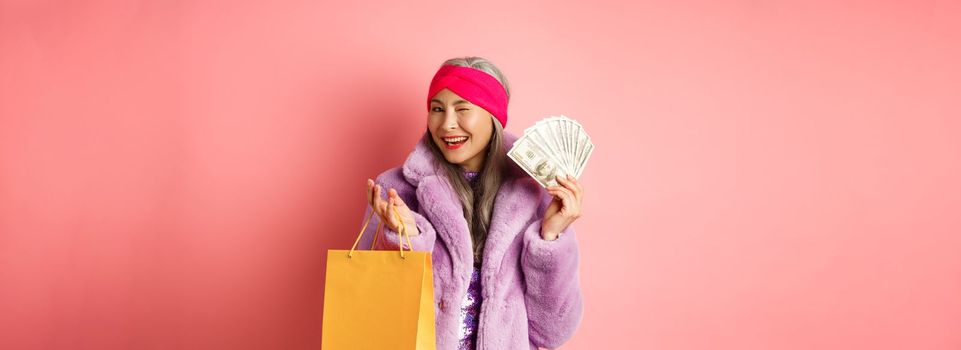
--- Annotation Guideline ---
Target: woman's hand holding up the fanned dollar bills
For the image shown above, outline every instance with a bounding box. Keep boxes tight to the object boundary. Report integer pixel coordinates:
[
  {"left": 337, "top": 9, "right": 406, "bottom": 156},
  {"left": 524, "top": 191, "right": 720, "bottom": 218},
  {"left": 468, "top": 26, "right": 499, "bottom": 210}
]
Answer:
[{"left": 541, "top": 176, "right": 584, "bottom": 241}]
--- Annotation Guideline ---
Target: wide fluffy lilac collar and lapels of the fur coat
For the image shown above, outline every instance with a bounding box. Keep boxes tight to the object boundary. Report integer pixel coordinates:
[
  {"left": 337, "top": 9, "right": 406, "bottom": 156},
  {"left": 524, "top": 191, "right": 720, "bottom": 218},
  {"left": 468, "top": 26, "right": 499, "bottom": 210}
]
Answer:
[{"left": 403, "top": 131, "right": 543, "bottom": 288}]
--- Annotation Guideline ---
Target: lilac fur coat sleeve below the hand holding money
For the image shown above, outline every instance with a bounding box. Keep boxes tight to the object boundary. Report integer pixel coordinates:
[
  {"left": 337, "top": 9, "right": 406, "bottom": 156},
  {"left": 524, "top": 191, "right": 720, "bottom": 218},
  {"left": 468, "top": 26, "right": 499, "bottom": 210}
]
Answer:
[{"left": 521, "top": 192, "right": 583, "bottom": 348}]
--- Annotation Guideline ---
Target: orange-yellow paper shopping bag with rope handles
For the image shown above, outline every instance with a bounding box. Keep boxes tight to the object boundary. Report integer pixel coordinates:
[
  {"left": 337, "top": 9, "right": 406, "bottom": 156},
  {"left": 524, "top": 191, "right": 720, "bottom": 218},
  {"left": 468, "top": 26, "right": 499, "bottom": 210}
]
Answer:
[{"left": 321, "top": 206, "right": 437, "bottom": 350}]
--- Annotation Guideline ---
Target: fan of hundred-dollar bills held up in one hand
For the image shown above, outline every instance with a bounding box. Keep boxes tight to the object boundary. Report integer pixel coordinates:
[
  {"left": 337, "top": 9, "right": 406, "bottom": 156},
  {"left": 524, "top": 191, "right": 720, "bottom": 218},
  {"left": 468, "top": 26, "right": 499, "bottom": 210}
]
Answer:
[{"left": 507, "top": 115, "right": 594, "bottom": 187}]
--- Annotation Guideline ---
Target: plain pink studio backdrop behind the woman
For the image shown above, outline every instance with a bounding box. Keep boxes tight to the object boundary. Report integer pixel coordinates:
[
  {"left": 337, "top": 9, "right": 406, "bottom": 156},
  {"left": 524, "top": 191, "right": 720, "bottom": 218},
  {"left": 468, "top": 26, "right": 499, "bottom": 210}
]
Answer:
[{"left": 0, "top": 0, "right": 961, "bottom": 349}]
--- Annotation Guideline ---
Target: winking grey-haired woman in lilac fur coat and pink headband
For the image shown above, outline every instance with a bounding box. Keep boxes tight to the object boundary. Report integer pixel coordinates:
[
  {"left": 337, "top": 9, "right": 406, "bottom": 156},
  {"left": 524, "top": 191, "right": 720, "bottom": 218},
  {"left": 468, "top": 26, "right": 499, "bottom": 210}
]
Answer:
[{"left": 361, "top": 57, "right": 584, "bottom": 349}]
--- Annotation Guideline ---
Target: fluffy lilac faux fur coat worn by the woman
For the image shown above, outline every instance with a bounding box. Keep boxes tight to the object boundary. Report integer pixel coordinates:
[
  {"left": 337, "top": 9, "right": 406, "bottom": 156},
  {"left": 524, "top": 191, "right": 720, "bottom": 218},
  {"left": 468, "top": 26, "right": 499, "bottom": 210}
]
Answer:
[{"left": 360, "top": 132, "right": 583, "bottom": 350}]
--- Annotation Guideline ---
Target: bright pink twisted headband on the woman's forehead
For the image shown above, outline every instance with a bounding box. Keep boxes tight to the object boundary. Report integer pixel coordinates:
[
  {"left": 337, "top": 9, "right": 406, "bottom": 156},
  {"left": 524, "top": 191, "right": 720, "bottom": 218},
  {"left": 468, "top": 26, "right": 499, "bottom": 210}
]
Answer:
[{"left": 427, "top": 65, "right": 508, "bottom": 128}]
